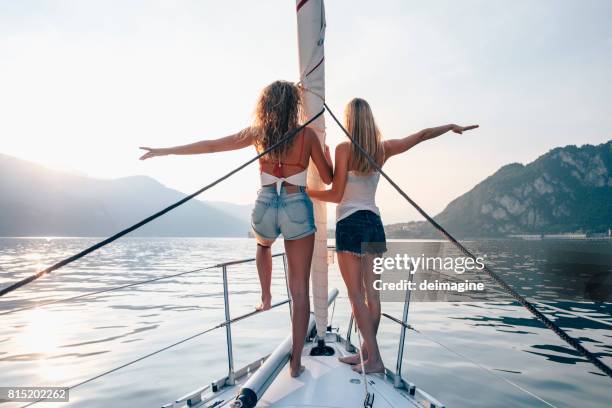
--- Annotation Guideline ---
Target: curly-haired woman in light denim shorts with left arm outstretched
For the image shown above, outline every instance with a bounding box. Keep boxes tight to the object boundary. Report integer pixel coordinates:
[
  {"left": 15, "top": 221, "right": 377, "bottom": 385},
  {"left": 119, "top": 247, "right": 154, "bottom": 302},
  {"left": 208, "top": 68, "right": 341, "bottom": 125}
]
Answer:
[{"left": 141, "top": 81, "right": 332, "bottom": 377}]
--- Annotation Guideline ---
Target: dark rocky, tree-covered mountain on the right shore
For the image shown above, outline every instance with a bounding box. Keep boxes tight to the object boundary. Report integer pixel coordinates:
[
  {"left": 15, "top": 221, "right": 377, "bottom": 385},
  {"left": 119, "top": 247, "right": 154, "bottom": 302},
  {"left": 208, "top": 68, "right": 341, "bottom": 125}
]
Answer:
[{"left": 387, "top": 141, "right": 612, "bottom": 238}]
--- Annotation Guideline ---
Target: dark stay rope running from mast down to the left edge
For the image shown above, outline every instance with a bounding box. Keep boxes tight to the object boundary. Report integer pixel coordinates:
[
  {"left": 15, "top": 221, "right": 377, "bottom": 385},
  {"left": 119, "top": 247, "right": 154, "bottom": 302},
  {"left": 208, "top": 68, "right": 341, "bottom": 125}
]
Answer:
[{"left": 0, "top": 109, "right": 325, "bottom": 296}]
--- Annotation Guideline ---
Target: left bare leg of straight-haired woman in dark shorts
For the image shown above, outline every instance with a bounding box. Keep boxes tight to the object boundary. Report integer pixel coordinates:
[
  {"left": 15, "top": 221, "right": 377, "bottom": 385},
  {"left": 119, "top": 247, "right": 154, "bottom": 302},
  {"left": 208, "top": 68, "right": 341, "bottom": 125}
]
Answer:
[{"left": 338, "top": 252, "right": 384, "bottom": 373}]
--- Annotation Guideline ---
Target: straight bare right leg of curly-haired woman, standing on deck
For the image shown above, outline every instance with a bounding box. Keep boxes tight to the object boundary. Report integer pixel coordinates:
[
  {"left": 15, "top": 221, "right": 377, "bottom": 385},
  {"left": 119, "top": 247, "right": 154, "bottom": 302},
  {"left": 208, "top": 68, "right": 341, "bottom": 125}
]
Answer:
[{"left": 285, "top": 234, "right": 314, "bottom": 377}]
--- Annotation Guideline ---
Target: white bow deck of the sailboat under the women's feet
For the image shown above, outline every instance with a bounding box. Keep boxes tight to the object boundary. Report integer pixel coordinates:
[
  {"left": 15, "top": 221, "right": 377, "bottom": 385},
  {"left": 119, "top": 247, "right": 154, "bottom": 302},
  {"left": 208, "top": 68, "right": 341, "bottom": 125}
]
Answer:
[{"left": 162, "top": 280, "right": 444, "bottom": 408}]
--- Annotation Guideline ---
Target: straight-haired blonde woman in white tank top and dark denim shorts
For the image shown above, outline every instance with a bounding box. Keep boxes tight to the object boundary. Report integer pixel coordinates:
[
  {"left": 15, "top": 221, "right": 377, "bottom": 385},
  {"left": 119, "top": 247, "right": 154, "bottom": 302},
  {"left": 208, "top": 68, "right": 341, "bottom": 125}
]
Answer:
[{"left": 308, "top": 98, "right": 478, "bottom": 373}]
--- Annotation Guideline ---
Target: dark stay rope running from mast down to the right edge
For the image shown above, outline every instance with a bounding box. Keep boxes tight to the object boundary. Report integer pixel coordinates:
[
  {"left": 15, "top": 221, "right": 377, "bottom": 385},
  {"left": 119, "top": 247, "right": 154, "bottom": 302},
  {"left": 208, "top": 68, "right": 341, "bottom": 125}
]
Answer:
[{"left": 323, "top": 102, "right": 612, "bottom": 377}]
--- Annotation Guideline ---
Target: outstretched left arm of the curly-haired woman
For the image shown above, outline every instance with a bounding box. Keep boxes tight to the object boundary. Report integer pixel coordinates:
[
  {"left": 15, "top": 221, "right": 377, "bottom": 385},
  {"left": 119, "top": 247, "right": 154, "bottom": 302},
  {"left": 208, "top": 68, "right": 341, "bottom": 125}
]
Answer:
[{"left": 140, "top": 128, "right": 253, "bottom": 160}]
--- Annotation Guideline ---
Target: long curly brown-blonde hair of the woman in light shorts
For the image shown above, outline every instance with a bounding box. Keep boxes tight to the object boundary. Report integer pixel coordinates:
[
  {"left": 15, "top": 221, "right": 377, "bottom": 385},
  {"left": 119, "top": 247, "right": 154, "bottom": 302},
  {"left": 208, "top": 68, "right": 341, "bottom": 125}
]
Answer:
[{"left": 252, "top": 81, "right": 302, "bottom": 161}]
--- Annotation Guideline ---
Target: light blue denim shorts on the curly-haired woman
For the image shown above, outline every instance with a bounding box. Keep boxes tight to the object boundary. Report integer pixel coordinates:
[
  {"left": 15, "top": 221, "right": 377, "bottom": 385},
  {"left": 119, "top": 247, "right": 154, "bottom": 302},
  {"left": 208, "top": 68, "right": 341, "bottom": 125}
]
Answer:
[{"left": 251, "top": 186, "right": 317, "bottom": 241}]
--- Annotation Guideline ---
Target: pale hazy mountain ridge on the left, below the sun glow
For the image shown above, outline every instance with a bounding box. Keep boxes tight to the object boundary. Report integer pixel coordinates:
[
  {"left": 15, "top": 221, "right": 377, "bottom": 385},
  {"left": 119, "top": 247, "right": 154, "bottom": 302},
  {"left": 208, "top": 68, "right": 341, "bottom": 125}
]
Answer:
[{"left": 0, "top": 154, "right": 250, "bottom": 237}]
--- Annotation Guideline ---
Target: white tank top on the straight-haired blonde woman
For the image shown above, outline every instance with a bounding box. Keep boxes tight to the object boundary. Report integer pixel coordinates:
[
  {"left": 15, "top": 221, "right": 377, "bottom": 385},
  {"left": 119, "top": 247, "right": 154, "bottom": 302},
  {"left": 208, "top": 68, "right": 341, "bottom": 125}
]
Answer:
[{"left": 336, "top": 171, "right": 380, "bottom": 222}]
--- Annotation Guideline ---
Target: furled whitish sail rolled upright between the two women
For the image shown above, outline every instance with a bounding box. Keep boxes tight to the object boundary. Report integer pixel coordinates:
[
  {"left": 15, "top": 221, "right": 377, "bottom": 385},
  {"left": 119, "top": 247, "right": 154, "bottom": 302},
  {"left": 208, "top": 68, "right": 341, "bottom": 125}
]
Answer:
[{"left": 296, "top": 0, "right": 328, "bottom": 337}]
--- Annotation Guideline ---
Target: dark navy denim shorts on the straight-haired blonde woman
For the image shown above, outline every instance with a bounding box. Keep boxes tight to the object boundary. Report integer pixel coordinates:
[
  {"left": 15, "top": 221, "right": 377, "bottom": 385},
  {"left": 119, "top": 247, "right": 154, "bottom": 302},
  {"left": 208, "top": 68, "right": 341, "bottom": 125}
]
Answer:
[{"left": 336, "top": 210, "right": 387, "bottom": 256}]
